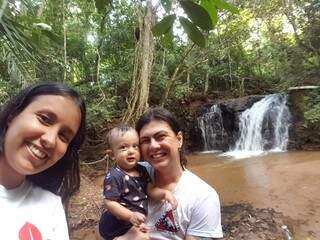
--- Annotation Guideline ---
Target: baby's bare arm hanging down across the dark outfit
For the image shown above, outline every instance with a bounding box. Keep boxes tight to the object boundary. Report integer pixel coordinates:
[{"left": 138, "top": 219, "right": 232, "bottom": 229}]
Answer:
[{"left": 105, "top": 199, "right": 146, "bottom": 227}]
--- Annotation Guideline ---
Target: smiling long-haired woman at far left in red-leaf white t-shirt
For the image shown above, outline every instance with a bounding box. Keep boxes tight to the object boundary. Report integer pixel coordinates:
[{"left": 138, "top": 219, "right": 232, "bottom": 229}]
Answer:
[{"left": 0, "top": 83, "right": 86, "bottom": 240}]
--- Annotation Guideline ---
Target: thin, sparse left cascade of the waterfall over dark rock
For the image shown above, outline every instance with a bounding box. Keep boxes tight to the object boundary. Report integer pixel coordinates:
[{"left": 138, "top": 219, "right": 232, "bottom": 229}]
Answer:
[{"left": 197, "top": 104, "right": 225, "bottom": 151}]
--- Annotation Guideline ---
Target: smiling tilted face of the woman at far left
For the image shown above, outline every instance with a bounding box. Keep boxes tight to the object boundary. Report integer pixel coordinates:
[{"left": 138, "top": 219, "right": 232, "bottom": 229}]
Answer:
[{"left": 2, "top": 95, "right": 81, "bottom": 176}]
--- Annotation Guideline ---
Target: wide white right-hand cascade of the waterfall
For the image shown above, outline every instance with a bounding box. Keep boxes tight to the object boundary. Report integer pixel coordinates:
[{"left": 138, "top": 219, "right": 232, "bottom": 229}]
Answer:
[{"left": 234, "top": 94, "right": 291, "bottom": 152}]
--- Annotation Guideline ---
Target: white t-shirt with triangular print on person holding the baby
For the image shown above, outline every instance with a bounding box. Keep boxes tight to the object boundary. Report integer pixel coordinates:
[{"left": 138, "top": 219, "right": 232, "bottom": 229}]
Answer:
[{"left": 146, "top": 169, "right": 223, "bottom": 240}]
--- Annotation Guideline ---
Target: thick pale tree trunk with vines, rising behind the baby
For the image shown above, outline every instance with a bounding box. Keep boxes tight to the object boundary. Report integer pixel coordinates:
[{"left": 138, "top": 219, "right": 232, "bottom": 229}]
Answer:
[{"left": 122, "top": 0, "right": 155, "bottom": 123}]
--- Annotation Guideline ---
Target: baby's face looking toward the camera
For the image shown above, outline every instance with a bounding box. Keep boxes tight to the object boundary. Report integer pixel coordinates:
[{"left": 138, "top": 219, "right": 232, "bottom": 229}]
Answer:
[{"left": 112, "top": 129, "right": 140, "bottom": 171}]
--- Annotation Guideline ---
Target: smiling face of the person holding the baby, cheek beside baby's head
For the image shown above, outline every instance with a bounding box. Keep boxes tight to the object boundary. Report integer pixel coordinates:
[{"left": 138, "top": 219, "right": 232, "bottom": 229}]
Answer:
[{"left": 139, "top": 120, "right": 183, "bottom": 170}]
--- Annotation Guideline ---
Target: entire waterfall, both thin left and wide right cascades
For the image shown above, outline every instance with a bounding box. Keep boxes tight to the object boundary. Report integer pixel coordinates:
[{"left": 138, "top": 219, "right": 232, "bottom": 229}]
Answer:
[{"left": 196, "top": 94, "right": 291, "bottom": 158}]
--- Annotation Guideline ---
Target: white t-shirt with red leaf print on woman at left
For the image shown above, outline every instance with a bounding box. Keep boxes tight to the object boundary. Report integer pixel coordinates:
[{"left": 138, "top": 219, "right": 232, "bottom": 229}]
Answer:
[{"left": 0, "top": 181, "right": 69, "bottom": 240}]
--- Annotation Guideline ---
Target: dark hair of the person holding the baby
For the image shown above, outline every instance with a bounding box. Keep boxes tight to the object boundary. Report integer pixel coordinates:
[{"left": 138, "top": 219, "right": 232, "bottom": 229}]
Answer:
[{"left": 136, "top": 107, "right": 187, "bottom": 169}]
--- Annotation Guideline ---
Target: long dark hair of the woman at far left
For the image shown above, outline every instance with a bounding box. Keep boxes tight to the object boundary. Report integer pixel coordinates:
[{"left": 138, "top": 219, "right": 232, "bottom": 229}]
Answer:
[{"left": 0, "top": 82, "right": 86, "bottom": 201}]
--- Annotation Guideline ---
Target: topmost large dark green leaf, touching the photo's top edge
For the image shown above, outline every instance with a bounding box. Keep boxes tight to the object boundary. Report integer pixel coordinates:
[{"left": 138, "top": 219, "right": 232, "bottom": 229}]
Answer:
[{"left": 180, "top": 0, "right": 213, "bottom": 30}]
